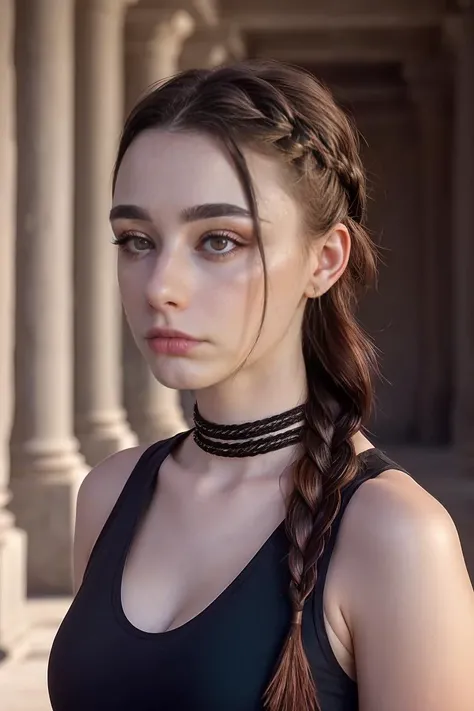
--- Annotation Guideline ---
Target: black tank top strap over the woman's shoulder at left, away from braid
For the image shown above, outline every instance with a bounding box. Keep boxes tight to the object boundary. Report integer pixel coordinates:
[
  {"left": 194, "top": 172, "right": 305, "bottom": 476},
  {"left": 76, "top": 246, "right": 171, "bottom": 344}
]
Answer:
[{"left": 84, "top": 432, "right": 188, "bottom": 580}]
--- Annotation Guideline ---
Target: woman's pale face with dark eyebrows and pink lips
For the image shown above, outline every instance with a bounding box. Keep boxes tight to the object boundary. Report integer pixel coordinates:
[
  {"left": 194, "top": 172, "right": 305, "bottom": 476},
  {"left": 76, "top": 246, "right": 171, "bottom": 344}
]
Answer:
[{"left": 111, "top": 129, "right": 314, "bottom": 390}]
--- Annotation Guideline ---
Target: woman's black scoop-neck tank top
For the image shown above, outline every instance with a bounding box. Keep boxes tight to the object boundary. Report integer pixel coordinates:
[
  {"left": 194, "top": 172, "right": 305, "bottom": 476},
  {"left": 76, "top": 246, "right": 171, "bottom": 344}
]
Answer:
[{"left": 48, "top": 438, "right": 406, "bottom": 711}]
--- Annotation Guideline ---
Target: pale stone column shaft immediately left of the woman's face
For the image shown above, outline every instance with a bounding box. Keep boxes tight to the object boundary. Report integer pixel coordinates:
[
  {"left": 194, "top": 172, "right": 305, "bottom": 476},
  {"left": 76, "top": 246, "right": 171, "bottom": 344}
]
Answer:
[{"left": 74, "top": 0, "right": 136, "bottom": 465}]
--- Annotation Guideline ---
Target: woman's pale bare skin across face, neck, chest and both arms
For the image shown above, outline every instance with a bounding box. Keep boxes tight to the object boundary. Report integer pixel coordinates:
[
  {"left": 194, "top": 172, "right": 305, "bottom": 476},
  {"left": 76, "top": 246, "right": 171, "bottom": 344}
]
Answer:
[{"left": 74, "top": 130, "right": 474, "bottom": 711}]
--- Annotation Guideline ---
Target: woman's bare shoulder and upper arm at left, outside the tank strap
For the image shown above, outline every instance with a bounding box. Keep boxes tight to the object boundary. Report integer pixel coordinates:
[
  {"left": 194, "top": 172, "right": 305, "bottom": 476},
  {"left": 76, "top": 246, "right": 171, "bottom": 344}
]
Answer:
[{"left": 73, "top": 447, "right": 145, "bottom": 592}]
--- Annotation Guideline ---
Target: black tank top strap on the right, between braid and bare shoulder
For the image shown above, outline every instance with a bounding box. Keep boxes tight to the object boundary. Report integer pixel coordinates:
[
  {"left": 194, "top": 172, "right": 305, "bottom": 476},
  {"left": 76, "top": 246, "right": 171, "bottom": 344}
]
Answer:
[{"left": 315, "top": 448, "right": 408, "bottom": 603}]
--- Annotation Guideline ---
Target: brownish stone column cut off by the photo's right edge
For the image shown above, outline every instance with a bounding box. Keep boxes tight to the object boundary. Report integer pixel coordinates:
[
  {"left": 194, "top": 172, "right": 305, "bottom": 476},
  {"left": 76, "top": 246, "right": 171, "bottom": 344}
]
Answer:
[{"left": 446, "top": 2, "right": 474, "bottom": 475}]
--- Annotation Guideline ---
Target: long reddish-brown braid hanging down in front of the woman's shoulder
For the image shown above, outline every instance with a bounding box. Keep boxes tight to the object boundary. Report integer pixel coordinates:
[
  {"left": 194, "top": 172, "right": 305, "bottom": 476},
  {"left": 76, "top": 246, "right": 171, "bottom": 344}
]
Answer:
[{"left": 265, "top": 294, "right": 375, "bottom": 711}]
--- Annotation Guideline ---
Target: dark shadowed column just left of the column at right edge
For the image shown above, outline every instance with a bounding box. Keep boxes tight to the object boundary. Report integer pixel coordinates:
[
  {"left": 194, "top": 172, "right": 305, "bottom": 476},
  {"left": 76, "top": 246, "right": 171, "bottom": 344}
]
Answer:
[{"left": 405, "top": 58, "right": 452, "bottom": 446}]
